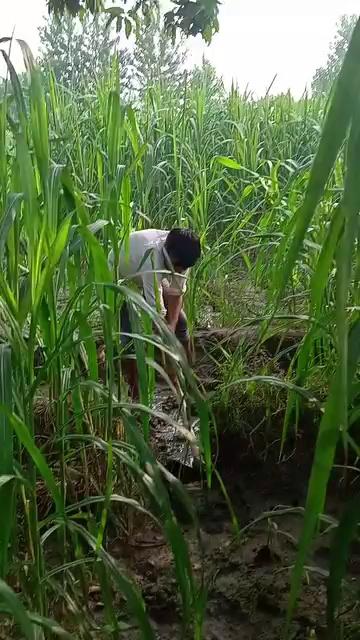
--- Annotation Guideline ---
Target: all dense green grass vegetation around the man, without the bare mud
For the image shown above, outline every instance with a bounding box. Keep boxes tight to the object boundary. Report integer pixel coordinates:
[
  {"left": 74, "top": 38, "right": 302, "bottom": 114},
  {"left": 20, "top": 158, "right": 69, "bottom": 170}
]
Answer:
[{"left": 0, "top": 11, "right": 360, "bottom": 639}]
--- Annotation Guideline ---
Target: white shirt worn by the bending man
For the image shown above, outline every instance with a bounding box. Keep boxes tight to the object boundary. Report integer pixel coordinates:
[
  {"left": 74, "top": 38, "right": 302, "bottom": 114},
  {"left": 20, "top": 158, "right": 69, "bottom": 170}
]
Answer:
[{"left": 109, "top": 229, "right": 187, "bottom": 317}]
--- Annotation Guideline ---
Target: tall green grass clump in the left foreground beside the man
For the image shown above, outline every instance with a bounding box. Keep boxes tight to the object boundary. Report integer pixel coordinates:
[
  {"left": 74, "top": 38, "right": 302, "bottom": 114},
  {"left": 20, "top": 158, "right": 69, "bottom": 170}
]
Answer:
[{"left": 0, "top": 40, "right": 211, "bottom": 639}]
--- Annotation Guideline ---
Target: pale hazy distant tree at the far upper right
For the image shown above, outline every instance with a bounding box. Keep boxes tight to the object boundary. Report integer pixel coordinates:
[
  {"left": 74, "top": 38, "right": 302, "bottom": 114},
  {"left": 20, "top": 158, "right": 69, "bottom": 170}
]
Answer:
[{"left": 311, "top": 15, "right": 358, "bottom": 95}]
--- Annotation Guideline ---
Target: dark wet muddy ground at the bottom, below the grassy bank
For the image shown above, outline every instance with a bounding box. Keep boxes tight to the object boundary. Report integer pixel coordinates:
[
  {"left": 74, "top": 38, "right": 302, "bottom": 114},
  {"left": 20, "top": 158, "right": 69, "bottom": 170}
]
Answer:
[{"left": 105, "top": 384, "right": 360, "bottom": 640}]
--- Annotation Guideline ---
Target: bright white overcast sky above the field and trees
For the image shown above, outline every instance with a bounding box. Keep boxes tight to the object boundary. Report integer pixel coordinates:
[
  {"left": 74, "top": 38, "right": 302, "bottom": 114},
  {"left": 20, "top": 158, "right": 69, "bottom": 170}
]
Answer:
[{"left": 0, "top": 0, "right": 360, "bottom": 96}]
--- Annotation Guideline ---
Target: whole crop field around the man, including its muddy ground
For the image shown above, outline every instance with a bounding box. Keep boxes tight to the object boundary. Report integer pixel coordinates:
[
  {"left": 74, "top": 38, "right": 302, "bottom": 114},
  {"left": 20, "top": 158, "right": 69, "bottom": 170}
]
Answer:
[{"left": 0, "top": 18, "right": 360, "bottom": 640}]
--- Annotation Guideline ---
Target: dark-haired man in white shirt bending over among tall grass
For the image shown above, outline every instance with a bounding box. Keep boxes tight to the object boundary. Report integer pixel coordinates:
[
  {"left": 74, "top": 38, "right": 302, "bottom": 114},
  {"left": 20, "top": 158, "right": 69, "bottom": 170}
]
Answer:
[{"left": 109, "top": 229, "right": 201, "bottom": 397}]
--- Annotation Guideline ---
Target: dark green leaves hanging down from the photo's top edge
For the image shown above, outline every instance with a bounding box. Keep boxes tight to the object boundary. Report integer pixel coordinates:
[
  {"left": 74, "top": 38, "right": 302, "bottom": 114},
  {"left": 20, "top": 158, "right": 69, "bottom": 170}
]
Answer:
[{"left": 47, "top": 0, "right": 219, "bottom": 42}]
